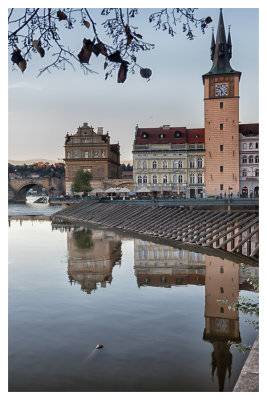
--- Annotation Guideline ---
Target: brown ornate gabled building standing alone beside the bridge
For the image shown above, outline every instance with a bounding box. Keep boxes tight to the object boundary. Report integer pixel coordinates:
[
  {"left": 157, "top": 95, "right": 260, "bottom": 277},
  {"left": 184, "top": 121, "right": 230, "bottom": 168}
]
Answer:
[{"left": 64, "top": 123, "right": 120, "bottom": 193}]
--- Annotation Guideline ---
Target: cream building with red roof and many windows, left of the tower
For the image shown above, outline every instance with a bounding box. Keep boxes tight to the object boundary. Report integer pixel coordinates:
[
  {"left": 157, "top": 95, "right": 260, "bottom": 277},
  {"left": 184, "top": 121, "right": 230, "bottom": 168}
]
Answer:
[{"left": 133, "top": 125, "right": 205, "bottom": 197}]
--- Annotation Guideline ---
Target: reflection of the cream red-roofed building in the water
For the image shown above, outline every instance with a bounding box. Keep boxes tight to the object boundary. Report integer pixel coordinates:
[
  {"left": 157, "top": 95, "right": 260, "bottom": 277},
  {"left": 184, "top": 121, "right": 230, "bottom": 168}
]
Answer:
[{"left": 134, "top": 239, "right": 205, "bottom": 287}]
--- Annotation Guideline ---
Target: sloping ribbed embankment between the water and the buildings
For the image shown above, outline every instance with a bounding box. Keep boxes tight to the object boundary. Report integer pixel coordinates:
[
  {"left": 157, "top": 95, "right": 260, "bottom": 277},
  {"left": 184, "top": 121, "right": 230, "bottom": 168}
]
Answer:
[{"left": 52, "top": 200, "right": 258, "bottom": 261}]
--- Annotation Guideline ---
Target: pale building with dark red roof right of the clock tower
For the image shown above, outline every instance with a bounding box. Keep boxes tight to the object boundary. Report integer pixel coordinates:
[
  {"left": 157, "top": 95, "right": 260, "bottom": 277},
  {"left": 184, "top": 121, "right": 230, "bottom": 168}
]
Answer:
[{"left": 239, "top": 124, "right": 259, "bottom": 197}]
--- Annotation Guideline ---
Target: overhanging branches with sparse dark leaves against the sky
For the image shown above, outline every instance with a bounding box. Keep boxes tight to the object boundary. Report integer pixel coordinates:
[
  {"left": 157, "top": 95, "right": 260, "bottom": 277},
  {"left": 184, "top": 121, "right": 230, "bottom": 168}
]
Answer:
[{"left": 8, "top": 8, "right": 212, "bottom": 83}]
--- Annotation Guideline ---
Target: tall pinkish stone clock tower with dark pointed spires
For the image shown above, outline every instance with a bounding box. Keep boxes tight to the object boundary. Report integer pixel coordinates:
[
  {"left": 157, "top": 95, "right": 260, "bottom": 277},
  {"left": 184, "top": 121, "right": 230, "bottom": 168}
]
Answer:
[{"left": 202, "top": 9, "right": 241, "bottom": 196}]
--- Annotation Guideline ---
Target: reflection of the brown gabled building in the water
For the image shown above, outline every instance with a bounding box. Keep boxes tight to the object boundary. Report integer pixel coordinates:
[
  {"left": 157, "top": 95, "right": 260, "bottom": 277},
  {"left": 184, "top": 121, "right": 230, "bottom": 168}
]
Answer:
[{"left": 67, "top": 229, "right": 121, "bottom": 294}]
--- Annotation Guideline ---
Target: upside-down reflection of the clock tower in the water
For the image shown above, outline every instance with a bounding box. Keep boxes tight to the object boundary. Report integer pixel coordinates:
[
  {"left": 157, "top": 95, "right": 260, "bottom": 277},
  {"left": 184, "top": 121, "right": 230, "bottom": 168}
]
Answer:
[{"left": 203, "top": 256, "right": 241, "bottom": 391}]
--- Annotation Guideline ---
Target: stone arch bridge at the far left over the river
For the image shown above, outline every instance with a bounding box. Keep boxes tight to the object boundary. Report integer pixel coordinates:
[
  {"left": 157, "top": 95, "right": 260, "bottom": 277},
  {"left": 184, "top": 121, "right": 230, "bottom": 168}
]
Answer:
[{"left": 8, "top": 177, "right": 65, "bottom": 203}]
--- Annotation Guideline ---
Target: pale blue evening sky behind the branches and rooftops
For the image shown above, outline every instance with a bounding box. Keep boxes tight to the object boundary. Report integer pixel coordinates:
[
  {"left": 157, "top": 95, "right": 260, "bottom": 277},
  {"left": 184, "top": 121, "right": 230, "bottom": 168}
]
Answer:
[{"left": 8, "top": 4, "right": 259, "bottom": 162}]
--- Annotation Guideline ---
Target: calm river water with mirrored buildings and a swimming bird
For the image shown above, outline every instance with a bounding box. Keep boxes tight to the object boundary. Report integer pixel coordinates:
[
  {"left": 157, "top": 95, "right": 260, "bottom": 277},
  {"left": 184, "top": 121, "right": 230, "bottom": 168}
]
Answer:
[{"left": 9, "top": 198, "right": 258, "bottom": 392}]
